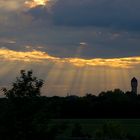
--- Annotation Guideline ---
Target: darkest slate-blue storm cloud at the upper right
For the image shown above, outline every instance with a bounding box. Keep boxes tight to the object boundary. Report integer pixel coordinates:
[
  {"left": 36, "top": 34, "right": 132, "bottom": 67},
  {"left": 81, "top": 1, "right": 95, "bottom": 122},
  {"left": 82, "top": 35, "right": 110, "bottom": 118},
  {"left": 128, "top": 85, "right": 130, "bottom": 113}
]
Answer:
[{"left": 27, "top": 0, "right": 140, "bottom": 30}]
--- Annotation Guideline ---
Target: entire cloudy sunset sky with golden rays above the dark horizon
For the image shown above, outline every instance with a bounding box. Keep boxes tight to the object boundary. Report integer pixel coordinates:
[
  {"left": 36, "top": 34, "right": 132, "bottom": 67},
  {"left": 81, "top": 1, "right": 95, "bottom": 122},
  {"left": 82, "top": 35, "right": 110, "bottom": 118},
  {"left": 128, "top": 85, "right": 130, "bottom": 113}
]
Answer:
[{"left": 0, "top": 0, "right": 140, "bottom": 96}]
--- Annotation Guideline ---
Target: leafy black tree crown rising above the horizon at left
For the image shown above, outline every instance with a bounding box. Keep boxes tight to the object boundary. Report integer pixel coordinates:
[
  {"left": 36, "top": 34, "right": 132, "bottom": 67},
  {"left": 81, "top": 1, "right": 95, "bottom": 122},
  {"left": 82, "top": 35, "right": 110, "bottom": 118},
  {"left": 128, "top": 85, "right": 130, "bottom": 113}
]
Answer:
[{"left": 2, "top": 70, "right": 43, "bottom": 98}]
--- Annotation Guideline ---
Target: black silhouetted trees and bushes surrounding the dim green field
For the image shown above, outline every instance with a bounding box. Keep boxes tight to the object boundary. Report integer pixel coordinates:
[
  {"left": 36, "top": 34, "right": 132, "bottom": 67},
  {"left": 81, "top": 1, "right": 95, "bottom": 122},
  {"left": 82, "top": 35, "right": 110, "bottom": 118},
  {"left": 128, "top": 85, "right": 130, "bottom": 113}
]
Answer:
[{"left": 0, "top": 70, "right": 140, "bottom": 140}]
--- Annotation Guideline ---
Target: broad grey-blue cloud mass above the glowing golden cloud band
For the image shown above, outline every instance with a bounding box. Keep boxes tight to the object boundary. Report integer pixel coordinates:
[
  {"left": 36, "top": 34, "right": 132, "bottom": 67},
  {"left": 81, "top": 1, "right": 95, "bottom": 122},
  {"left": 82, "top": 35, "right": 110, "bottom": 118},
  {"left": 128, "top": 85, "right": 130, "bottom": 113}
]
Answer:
[{"left": 0, "top": 0, "right": 140, "bottom": 58}]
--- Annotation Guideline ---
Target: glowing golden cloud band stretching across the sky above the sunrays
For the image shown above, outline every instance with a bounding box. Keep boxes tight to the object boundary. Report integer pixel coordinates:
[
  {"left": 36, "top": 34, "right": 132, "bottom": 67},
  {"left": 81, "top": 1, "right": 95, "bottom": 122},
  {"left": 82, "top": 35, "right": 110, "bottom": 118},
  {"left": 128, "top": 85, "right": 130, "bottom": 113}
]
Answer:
[{"left": 0, "top": 48, "right": 140, "bottom": 68}]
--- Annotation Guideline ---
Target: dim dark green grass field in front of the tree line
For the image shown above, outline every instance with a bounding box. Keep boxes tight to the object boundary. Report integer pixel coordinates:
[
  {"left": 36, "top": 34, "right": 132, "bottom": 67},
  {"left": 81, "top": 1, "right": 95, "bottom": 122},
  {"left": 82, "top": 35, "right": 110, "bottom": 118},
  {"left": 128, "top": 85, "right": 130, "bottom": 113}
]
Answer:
[{"left": 52, "top": 119, "right": 140, "bottom": 136}]
